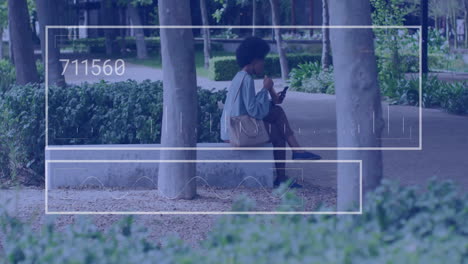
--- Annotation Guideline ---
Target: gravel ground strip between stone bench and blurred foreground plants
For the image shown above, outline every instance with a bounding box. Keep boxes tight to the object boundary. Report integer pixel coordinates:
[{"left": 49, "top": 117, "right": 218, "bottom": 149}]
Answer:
[{"left": 0, "top": 182, "right": 336, "bottom": 246}]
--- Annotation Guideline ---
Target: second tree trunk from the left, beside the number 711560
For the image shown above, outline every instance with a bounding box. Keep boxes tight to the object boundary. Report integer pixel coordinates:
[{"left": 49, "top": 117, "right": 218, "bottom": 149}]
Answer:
[{"left": 36, "top": 0, "right": 65, "bottom": 87}]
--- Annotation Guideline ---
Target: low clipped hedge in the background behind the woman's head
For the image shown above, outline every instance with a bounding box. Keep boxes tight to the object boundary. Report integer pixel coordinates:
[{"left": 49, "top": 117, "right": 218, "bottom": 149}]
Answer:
[{"left": 209, "top": 53, "right": 321, "bottom": 81}]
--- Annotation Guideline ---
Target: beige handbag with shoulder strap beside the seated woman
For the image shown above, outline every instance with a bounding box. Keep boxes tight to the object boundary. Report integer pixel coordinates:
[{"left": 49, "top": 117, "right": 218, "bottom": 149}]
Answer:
[{"left": 229, "top": 76, "right": 270, "bottom": 147}]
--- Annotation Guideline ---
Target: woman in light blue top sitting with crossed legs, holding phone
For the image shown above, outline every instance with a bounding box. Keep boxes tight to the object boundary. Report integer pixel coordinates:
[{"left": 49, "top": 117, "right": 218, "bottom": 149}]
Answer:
[{"left": 221, "top": 37, "right": 321, "bottom": 188}]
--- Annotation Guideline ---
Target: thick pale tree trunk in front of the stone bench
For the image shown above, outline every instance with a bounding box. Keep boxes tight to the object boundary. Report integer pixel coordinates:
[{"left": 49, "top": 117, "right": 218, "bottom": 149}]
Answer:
[{"left": 158, "top": 0, "right": 198, "bottom": 199}]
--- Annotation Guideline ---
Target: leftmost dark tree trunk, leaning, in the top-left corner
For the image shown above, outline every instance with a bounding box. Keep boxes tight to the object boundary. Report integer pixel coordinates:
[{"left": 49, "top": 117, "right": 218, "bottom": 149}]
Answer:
[{"left": 8, "top": 0, "right": 39, "bottom": 85}]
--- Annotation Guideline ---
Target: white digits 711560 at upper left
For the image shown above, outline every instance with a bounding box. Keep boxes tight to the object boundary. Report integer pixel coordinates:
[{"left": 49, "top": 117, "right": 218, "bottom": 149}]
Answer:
[{"left": 60, "top": 59, "right": 125, "bottom": 76}]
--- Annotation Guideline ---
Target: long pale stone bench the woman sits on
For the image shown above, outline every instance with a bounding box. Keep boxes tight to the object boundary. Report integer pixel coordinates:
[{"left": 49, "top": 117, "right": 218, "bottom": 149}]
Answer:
[{"left": 45, "top": 143, "right": 276, "bottom": 189}]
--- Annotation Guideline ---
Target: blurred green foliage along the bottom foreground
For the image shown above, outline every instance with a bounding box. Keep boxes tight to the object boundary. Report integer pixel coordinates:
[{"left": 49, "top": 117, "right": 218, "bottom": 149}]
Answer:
[{"left": 0, "top": 178, "right": 468, "bottom": 264}]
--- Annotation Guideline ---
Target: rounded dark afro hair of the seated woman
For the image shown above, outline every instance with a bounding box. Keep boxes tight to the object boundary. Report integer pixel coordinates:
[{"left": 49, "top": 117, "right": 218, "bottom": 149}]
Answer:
[{"left": 236, "top": 37, "right": 270, "bottom": 68}]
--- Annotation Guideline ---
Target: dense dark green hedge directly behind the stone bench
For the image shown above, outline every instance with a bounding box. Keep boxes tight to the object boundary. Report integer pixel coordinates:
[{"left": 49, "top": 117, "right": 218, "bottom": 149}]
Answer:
[{"left": 0, "top": 80, "right": 226, "bottom": 184}]
